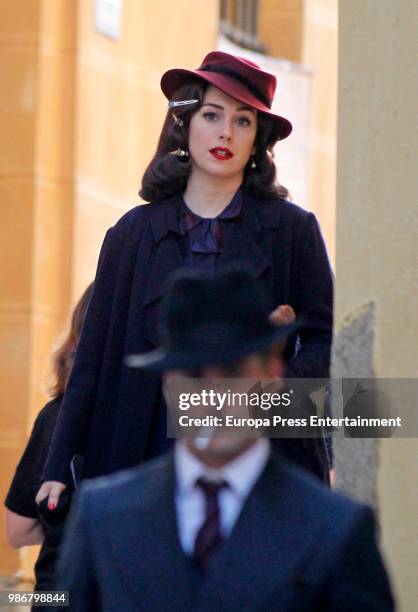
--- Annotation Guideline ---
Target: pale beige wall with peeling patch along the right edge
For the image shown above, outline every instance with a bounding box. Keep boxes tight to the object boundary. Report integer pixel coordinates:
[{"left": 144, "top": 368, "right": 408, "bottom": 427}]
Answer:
[{"left": 336, "top": 0, "right": 418, "bottom": 612}]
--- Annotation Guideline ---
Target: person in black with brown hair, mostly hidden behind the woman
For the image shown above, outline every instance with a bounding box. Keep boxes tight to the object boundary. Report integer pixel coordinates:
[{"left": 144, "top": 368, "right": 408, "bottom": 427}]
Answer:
[{"left": 5, "top": 285, "right": 93, "bottom": 596}]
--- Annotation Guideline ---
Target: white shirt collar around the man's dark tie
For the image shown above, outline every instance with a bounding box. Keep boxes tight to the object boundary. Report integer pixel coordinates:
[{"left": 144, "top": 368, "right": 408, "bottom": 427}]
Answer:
[{"left": 174, "top": 438, "right": 270, "bottom": 499}]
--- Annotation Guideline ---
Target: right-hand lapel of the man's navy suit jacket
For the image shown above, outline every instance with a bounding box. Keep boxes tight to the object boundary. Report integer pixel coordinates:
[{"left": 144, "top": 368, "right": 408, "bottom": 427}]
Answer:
[{"left": 199, "top": 457, "right": 317, "bottom": 610}]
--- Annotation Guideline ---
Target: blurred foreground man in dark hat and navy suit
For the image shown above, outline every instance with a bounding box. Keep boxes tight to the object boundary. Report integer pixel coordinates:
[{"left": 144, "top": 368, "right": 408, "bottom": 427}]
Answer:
[{"left": 57, "top": 271, "right": 394, "bottom": 612}]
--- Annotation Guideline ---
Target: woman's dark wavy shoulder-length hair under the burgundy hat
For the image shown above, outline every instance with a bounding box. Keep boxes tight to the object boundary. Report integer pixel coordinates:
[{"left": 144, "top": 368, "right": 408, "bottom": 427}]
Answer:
[{"left": 139, "top": 79, "right": 289, "bottom": 202}]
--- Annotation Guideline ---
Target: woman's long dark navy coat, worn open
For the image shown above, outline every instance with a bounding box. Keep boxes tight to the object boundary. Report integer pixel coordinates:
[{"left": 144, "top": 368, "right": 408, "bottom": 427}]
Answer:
[{"left": 43, "top": 194, "right": 332, "bottom": 483}]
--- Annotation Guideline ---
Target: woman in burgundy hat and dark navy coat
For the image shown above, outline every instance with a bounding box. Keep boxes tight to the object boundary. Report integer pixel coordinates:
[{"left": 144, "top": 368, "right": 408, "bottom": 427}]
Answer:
[{"left": 37, "top": 51, "right": 332, "bottom": 508}]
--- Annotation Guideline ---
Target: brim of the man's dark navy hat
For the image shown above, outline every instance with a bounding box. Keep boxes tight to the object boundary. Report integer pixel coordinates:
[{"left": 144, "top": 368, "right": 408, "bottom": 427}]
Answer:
[{"left": 125, "top": 321, "right": 302, "bottom": 373}]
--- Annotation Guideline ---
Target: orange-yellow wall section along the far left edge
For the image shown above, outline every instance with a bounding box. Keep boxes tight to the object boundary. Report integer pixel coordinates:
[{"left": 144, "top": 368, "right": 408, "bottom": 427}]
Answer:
[{"left": 0, "top": 0, "right": 74, "bottom": 573}]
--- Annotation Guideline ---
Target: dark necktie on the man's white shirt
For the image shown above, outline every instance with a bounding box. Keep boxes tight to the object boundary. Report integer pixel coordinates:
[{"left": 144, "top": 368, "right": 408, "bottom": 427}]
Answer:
[{"left": 194, "top": 478, "right": 228, "bottom": 568}]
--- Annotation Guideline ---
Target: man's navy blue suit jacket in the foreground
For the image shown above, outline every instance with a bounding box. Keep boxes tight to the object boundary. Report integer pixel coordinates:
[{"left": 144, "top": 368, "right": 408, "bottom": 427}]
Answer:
[{"left": 57, "top": 454, "right": 393, "bottom": 612}]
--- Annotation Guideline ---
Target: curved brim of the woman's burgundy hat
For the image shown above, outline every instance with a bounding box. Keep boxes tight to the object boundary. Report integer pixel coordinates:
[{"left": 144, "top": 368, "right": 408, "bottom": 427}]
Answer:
[{"left": 161, "top": 68, "right": 293, "bottom": 140}]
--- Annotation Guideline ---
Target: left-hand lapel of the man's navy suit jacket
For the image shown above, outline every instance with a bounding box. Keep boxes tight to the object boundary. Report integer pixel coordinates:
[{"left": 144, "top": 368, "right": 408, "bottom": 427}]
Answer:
[{"left": 103, "top": 453, "right": 192, "bottom": 610}]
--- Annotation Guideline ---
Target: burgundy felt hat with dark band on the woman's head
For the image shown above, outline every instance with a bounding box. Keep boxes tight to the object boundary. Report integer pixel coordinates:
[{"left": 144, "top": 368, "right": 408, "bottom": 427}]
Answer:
[{"left": 161, "top": 51, "right": 292, "bottom": 140}]
